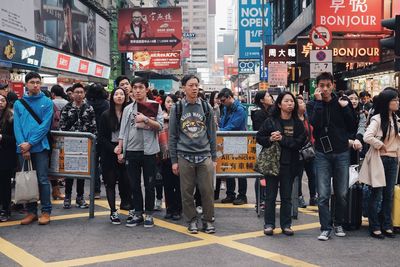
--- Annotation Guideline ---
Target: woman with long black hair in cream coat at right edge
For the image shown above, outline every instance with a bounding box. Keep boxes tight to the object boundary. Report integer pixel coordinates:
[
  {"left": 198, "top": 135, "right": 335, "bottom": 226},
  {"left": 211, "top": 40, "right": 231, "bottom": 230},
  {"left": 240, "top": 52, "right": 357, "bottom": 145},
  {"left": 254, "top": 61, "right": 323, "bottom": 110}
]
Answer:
[{"left": 360, "top": 87, "right": 400, "bottom": 239}]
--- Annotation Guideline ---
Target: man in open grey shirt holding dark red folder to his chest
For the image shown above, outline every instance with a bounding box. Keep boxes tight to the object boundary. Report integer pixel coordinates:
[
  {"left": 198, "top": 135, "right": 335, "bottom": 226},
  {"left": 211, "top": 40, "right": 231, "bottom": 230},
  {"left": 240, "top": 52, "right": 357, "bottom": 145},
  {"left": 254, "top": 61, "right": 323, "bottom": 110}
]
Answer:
[{"left": 116, "top": 78, "right": 164, "bottom": 227}]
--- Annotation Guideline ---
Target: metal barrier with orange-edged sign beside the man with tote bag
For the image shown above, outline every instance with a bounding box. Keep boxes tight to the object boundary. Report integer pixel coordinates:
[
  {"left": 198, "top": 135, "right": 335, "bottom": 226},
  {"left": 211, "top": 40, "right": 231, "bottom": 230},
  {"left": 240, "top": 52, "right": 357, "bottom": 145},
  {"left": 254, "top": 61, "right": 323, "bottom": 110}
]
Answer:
[{"left": 49, "top": 131, "right": 96, "bottom": 218}]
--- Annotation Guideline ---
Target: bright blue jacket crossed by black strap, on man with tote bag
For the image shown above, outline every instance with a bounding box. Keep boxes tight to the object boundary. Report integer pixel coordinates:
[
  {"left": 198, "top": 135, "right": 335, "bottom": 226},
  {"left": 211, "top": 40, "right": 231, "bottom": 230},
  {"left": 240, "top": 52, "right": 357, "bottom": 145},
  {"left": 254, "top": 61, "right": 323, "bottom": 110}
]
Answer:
[{"left": 14, "top": 92, "right": 53, "bottom": 153}]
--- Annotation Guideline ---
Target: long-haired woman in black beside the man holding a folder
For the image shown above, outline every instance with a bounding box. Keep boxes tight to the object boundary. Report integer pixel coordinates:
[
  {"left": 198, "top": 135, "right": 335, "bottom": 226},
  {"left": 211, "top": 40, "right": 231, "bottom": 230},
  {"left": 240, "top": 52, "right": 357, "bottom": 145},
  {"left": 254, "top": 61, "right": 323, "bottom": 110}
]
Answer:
[{"left": 98, "top": 87, "right": 132, "bottom": 224}]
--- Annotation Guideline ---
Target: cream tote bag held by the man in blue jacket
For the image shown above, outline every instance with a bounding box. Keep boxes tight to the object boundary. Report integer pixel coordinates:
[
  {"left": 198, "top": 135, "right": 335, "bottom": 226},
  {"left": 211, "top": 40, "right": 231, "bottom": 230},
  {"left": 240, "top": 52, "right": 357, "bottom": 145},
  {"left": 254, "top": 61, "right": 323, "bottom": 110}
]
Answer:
[{"left": 15, "top": 160, "right": 39, "bottom": 204}]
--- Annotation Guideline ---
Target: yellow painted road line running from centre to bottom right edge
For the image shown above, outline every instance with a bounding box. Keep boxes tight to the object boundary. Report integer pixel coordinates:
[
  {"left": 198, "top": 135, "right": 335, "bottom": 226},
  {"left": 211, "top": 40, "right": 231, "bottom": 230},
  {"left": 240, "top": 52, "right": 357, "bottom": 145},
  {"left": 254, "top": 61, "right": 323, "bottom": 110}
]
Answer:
[{"left": 220, "top": 240, "right": 318, "bottom": 267}]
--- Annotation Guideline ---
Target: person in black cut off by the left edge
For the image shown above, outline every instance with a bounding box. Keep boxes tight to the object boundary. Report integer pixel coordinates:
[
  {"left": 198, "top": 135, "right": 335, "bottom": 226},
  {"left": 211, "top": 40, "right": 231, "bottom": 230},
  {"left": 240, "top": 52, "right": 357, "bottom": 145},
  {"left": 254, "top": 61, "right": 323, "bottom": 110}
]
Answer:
[{"left": 0, "top": 95, "right": 17, "bottom": 222}]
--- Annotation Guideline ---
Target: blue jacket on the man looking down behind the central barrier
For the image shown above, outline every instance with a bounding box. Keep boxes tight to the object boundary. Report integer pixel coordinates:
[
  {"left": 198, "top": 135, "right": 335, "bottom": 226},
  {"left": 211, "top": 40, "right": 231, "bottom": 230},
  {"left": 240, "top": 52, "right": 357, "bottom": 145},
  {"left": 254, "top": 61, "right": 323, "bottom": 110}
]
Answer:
[{"left": 219, "top": 99, "right": 246, "bottom": 131}]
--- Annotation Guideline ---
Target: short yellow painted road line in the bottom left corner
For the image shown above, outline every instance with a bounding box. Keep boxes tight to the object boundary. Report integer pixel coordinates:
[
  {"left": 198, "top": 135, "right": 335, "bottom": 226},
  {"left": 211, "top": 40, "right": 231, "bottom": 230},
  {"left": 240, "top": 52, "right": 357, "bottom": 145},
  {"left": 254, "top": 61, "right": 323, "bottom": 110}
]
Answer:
[{"left": 0, "top": 237, "right": 45, "bottom": 267}]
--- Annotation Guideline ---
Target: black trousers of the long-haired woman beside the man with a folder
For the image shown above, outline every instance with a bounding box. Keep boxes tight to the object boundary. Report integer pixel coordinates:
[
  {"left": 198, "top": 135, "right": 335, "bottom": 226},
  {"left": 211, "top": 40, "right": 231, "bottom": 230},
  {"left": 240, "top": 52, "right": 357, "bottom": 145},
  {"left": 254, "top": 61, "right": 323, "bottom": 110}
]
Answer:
[{"left": 102, "top": 157, "right": 132, "bottom": 211}]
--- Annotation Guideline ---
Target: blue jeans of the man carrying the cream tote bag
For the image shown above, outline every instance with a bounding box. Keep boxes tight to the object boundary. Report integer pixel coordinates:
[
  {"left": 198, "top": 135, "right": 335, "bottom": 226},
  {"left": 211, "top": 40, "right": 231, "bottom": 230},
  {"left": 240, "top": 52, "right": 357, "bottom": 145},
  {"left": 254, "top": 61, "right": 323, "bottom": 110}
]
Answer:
[{"left": 18, "top": 150, "right": 51, "bottom": 214}]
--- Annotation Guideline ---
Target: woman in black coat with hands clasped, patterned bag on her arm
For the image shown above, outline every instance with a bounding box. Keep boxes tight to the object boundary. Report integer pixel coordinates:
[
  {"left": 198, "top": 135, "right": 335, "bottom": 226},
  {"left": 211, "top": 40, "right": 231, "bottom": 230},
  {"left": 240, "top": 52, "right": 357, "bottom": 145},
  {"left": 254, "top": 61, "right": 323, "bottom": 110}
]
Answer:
[{"left": 256, "top": 92, "right": 306, "bottom": 235}]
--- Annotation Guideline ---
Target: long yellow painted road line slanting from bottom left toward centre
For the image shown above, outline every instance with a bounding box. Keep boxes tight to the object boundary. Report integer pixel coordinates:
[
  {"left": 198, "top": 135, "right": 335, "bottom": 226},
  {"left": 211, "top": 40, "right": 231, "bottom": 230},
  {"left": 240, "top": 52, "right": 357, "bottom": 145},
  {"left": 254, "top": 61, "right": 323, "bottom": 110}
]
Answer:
[{"left": 46, "top": 240, "right": 213, "bottom": 267}]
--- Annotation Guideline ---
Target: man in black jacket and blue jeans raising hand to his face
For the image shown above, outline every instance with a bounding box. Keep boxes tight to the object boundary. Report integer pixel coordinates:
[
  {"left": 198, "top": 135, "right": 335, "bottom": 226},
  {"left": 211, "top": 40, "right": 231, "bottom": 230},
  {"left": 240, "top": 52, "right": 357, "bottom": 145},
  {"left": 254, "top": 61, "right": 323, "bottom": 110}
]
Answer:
[{"left": 311, "top": 72, "right": 357, "bottom": 241}]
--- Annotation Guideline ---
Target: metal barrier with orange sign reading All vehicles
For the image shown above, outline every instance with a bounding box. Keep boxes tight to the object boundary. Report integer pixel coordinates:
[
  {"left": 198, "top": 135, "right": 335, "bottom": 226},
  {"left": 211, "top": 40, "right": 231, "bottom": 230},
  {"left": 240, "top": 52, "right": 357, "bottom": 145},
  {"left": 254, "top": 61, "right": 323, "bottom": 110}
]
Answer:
[{"left": 216, "top": 131, "right": 264, "bottom": 216}]
